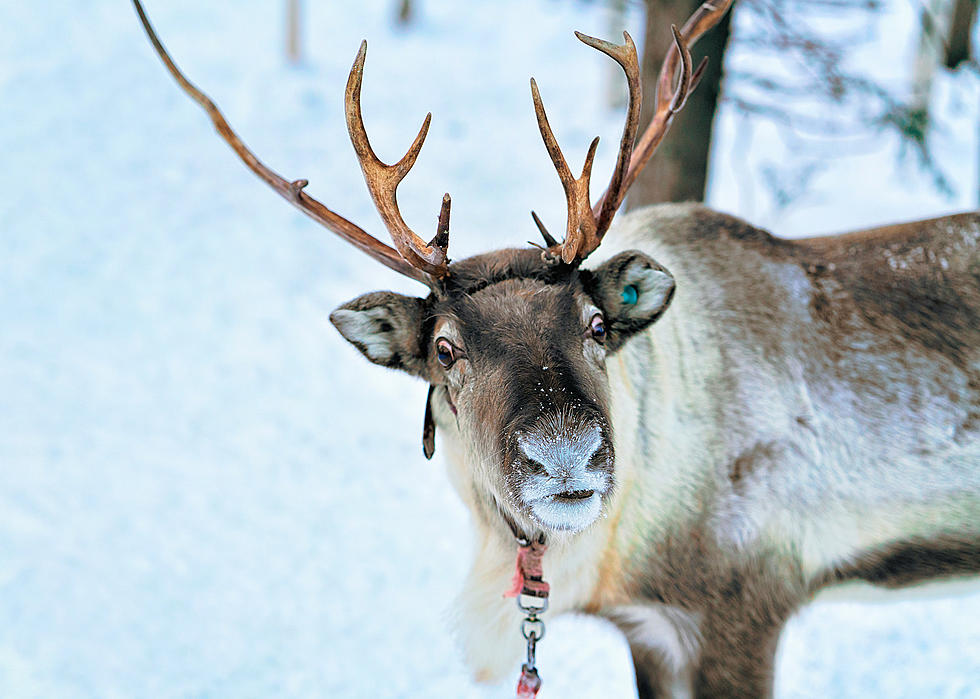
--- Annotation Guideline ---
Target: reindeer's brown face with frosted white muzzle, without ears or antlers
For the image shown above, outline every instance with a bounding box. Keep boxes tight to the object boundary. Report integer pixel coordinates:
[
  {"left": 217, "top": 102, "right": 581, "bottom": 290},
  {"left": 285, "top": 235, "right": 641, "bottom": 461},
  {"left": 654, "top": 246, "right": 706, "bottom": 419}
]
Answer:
[{"left": 433, "top": 279, "right": 613, "bottom": 530}]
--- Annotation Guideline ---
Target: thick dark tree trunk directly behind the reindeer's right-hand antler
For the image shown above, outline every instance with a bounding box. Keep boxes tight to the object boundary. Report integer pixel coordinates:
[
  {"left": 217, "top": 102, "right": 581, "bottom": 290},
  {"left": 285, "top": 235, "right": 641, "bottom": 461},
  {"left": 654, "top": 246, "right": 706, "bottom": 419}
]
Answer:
[{"left": 626, "top": 0, "right": 732, "bottom": 208}]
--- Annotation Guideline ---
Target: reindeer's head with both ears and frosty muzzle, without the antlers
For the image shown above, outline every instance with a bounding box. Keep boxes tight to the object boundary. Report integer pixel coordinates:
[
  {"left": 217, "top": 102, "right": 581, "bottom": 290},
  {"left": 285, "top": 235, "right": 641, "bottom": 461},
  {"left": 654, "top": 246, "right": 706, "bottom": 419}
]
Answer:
[{"left": 330, "top": 250, "right": 674, "bottom": 531}]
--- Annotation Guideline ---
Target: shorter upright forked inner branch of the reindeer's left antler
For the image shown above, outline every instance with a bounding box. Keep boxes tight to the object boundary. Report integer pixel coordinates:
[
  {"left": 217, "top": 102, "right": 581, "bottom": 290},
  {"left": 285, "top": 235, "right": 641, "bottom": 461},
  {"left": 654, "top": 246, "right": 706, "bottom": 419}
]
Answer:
[{"left": 344, "top": 41, "right": 449, "bottom": 278}]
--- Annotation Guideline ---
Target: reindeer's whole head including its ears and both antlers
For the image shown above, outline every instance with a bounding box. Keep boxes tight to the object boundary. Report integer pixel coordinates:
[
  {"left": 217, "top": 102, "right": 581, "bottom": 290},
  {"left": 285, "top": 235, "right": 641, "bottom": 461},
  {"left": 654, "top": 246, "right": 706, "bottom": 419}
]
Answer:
[{"left": 134, "top": 0, "right": 732, "bottom": 532}]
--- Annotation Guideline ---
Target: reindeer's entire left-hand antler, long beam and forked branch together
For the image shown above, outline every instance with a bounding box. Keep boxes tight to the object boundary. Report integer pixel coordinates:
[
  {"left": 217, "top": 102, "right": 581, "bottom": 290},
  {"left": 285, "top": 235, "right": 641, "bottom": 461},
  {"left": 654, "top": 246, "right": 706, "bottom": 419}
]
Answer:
[{"left": 133, "top": 0, "right": 449, "bottom": 287}]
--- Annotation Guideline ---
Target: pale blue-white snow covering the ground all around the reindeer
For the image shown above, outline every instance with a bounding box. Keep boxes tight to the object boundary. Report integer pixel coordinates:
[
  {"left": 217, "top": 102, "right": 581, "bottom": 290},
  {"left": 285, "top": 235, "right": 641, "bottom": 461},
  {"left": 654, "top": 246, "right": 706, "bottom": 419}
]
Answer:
[{"left": 0, "top": 0, "right": 980, "bottom": 697}]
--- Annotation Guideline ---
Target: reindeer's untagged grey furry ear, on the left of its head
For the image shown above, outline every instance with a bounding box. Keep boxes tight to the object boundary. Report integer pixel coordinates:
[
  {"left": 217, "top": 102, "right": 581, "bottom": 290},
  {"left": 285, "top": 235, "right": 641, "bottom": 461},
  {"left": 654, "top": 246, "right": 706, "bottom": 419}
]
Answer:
[{"left": 330, "top": 291, "right": 425, "bottom": 376}]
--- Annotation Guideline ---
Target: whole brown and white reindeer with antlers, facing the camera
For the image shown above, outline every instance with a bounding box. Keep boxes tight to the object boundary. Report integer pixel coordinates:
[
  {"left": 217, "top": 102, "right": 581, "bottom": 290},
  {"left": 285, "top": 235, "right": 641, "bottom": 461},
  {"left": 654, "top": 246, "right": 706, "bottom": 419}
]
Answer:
[{"left": 134, "top": 0, "right": 980, "bottom": 697}]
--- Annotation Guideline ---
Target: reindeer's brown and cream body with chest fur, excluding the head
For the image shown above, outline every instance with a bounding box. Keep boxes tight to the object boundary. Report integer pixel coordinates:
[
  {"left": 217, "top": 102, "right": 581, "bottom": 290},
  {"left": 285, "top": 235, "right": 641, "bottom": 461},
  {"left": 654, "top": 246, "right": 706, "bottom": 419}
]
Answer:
[{"left": 444, "top": 205, "right": 980, "bottom": 696}]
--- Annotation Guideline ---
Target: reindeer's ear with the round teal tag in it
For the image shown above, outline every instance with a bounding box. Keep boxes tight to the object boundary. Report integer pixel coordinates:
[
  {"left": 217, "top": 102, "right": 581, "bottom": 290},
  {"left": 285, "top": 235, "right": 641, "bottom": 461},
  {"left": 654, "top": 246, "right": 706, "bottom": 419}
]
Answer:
[{"left": 591, "top": 250, "right": 674, "bottom": 351}]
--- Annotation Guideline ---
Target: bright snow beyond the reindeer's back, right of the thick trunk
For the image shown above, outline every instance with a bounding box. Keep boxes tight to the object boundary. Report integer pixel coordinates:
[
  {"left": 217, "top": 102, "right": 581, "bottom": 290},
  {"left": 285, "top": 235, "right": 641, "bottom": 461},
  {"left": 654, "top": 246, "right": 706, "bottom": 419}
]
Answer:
[{"left": 709, "top": 2, "right": 980, "bottom": 237}]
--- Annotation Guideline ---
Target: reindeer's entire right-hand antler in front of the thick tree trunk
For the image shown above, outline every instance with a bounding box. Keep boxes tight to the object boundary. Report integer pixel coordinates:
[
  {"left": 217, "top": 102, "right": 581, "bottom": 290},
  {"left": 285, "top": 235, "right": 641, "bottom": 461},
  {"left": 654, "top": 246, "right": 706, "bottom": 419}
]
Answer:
[{"left": 531, "top": 0, "right": 733, "bottom": 263}]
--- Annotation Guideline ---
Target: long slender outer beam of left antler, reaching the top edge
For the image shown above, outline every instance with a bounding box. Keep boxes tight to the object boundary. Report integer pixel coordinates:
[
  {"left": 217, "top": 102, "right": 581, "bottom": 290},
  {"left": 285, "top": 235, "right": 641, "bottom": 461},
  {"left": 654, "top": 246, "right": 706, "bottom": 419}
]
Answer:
[{"left": 133, "top": 0, "right": 432, "bottom": 286}]
